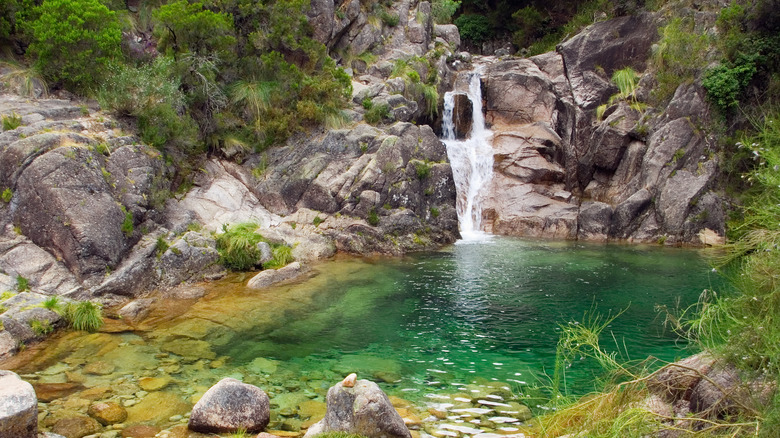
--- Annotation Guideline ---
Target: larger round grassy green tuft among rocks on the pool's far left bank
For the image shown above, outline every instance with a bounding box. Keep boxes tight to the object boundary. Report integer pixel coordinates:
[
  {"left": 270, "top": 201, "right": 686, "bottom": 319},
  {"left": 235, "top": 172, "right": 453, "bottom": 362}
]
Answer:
[{"left": 217, "top": 222, "right": 263, "bottom": 271}]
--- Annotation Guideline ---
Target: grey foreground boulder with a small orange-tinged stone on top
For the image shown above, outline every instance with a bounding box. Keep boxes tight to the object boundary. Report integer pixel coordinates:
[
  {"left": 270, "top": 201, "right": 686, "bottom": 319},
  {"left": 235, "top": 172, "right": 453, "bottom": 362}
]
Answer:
[{"left": 304, "top": 380, "right": 411, "bottom": 438}]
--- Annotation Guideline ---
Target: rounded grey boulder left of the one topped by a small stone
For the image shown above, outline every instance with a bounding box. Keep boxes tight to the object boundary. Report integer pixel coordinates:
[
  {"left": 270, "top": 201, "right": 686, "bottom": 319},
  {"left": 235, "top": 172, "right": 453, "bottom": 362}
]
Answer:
[{"left": 189, "top": 378, "right": 270, "bottom": 433}]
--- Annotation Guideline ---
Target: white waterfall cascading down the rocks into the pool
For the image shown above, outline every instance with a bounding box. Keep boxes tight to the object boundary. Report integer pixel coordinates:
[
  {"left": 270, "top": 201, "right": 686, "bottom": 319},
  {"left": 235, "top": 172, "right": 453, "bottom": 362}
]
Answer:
[{"left": 442, "top": 70, "right": 493, "bottom": 240}]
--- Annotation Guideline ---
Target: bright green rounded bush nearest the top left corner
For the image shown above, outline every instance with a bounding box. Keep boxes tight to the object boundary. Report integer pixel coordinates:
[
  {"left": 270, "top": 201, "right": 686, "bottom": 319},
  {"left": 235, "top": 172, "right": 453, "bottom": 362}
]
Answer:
[{"left": 27, "top": 0, "right": 122, "bottom": 91}]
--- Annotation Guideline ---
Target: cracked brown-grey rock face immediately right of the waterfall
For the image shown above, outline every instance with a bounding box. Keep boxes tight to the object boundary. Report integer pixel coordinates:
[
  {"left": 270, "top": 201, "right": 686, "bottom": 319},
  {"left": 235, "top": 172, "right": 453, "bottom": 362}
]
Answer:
[{"left": 464, "top": 14, "right": 724, "bottom": 244}]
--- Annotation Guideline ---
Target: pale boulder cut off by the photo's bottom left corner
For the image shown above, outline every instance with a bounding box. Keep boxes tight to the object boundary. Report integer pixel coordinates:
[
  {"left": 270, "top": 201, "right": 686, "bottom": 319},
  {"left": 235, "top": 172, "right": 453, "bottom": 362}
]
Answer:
[{"left": 0, "top": 370, "right": 38, "bottom": 438}]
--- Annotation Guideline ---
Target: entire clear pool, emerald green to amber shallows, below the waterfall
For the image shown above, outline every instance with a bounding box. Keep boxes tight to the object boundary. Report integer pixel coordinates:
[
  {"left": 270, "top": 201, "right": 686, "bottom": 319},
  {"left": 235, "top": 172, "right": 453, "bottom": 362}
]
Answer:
[{"left": 3, "top": 237, "right": 720, "bottom": 436}]
